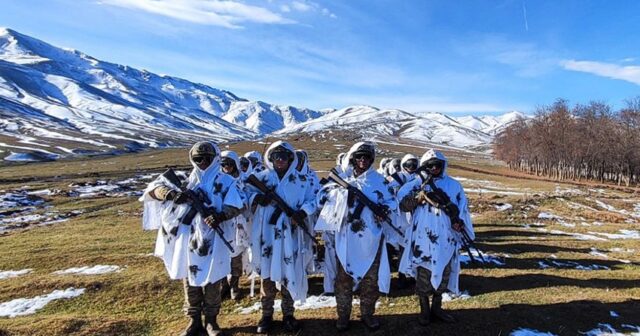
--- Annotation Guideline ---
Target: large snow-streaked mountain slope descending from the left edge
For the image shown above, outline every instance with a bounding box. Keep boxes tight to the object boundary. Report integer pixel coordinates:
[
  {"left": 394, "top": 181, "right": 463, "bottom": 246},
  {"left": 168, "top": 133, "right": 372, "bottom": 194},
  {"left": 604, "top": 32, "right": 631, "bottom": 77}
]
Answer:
[{"left": 0, "top": 29, "right": 322, "bottom": 157}]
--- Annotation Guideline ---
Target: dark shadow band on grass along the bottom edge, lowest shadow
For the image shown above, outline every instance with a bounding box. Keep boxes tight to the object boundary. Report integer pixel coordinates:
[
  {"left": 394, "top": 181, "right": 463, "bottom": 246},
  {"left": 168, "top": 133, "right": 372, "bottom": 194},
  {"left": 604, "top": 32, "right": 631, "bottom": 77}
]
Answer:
[{"left": 223, "top": 300, "right": 640, "bottom": 336}]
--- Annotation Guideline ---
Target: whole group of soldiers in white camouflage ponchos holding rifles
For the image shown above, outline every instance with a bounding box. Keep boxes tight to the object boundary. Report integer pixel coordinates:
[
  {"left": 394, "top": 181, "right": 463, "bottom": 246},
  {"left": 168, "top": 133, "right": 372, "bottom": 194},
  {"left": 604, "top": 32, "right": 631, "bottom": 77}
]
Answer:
[{"left": 141, "top": 141, "right": 475, "bottom": 335}]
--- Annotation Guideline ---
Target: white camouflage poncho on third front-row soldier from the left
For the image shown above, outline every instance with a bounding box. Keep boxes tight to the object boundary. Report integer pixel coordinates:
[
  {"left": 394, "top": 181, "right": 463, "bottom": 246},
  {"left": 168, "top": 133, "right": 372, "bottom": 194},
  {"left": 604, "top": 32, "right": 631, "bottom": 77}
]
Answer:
[{"left": 315, "top": 142, "right": 397, "bottom": 293}]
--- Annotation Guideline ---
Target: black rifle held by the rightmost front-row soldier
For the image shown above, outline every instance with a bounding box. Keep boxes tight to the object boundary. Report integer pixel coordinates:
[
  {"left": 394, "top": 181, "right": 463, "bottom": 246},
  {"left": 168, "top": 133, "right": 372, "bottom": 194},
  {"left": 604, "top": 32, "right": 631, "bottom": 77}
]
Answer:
[{"left": 419, "top": 172, "right": 486, "bottom": 263}]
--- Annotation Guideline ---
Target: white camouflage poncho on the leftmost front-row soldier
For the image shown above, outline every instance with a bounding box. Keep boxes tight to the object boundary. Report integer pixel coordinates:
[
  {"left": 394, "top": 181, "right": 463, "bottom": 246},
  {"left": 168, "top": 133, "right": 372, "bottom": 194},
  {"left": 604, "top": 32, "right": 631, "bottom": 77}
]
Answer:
[{"left": 140, "top": 144, "right": 243, "bottom": 286}]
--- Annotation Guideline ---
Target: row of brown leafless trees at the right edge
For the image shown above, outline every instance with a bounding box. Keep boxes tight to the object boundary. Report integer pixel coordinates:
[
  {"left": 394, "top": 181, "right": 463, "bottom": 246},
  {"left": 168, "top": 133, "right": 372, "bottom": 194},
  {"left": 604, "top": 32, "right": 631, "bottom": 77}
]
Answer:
[{"left": 494, "top": 96, "right": 640, "bottom": 186}]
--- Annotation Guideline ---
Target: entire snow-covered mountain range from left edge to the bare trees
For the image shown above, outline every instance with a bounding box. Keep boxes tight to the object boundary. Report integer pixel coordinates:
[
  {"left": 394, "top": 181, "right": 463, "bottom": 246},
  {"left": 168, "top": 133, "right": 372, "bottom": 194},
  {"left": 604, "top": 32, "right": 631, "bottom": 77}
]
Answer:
[{"left": 0, "top": 28, "right": 523, "bottom": 160}]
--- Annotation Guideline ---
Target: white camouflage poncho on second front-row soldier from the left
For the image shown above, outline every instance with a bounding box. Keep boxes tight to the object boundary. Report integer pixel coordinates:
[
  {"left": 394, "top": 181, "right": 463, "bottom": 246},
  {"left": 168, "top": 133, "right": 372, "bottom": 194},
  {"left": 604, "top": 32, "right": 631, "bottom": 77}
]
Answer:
[{"left": 247, "top": 141, "right": 315, "bottom": 300}]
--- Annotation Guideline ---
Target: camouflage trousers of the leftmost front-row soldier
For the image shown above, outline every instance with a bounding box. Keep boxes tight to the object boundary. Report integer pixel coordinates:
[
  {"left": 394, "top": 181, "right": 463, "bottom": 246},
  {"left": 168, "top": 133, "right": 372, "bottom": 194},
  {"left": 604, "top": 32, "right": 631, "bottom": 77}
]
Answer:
[{"left": 182, "top": 279, "right": 224, "bottom": 316}]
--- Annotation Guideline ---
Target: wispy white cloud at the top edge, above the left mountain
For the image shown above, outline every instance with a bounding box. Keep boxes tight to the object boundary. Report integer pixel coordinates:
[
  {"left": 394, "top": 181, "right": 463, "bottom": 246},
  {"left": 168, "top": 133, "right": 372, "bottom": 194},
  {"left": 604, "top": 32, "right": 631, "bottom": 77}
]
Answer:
[{"left": 99, "top": 0, "right": 295, "bottom": 29}]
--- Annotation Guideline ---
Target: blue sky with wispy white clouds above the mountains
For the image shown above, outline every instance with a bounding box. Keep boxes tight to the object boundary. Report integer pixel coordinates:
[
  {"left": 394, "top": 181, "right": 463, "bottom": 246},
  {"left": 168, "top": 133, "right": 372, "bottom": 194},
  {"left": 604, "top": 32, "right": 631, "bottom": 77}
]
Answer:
[{"left": 0, "top": 0, "right": 640, "bottom": 115}]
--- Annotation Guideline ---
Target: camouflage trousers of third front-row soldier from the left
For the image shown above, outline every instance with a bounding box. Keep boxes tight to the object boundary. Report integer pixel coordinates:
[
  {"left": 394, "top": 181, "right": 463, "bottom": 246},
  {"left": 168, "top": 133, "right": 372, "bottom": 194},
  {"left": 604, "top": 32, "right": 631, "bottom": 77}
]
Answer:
[{"left": 335, "top": 244, "right": 383, "bottom": 317}]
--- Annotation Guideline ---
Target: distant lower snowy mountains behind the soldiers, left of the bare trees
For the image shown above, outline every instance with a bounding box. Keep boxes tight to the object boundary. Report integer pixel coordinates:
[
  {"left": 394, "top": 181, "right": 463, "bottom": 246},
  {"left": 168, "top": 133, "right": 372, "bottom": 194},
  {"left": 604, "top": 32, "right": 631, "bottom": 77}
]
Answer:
[{"left": 278, "top": 106, "right": 524, "bottom": 148}]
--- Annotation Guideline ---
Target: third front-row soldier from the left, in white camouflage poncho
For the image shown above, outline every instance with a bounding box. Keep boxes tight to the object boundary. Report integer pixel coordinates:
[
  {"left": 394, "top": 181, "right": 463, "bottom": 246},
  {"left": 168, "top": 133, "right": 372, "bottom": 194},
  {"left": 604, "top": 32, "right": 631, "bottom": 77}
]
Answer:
[{"left": 316, "top": 142, "right": 397, "bottom": 331}]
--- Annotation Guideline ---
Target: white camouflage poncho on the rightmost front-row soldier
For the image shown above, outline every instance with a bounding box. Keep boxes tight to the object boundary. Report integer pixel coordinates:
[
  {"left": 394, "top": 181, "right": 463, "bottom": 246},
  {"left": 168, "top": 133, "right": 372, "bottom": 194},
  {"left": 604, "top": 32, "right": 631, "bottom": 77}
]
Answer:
[{"left": 398, "top": 150, "right": 475, "bottom": 293}]
